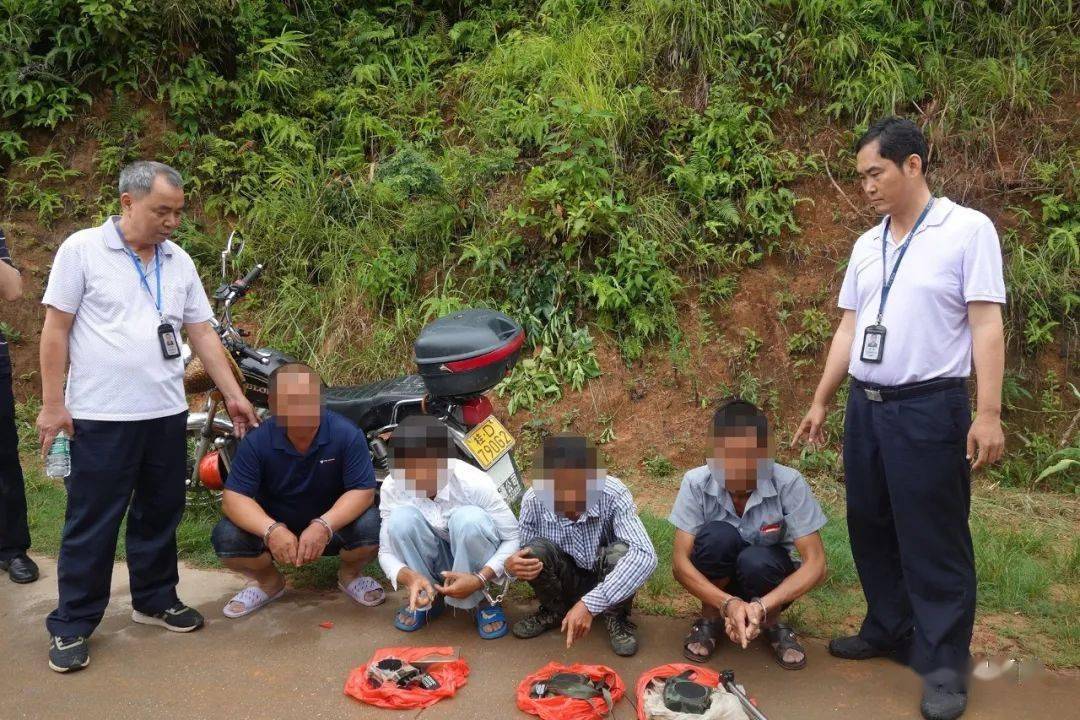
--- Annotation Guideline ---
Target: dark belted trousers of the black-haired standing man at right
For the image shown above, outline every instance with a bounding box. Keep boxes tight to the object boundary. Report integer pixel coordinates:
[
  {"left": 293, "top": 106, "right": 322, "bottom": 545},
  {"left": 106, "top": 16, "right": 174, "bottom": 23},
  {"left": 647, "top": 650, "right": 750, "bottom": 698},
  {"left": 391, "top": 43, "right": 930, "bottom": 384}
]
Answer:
[{"left": 843, "top": 379, "right": 975, "bottom": 684}]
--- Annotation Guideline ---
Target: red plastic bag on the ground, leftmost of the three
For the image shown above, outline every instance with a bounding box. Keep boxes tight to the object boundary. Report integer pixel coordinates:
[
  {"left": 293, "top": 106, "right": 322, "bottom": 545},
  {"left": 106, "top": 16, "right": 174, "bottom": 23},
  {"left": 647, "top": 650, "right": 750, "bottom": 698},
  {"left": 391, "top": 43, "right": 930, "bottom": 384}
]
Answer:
[{"left": 345, "top": 648, "right": 469, "bottom": 710}]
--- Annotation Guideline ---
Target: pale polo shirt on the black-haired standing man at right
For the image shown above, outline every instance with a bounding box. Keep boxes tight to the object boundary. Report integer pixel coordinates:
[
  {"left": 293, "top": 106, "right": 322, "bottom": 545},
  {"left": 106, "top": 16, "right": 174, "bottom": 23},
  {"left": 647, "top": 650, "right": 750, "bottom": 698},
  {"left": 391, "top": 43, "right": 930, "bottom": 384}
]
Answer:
[{"left": 839, "top": 198, "right": 1005, "bottom": 385}]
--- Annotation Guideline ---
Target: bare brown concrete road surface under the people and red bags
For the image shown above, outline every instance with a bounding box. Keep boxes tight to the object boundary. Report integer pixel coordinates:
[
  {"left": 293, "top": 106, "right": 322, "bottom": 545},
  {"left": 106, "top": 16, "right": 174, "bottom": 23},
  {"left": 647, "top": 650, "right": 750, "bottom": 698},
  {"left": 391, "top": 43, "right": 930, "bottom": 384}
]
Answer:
[{"left": 0, "top": 557, "right": 1080, "bottom": 720}]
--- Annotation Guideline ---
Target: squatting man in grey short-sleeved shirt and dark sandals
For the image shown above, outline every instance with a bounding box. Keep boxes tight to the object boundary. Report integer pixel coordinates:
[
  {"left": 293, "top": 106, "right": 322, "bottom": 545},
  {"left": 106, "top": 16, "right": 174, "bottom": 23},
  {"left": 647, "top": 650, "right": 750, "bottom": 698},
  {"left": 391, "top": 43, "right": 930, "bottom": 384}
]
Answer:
[{"left": 670, "top": 399, "right": 825, "bottom": 670}]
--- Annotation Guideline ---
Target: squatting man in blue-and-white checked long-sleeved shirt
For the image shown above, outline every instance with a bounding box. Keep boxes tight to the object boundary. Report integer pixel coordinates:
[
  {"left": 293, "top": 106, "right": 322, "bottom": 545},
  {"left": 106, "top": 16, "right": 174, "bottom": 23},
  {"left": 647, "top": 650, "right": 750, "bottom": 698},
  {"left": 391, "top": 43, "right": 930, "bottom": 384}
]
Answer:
[{"left": 505, "top": 435, "right": 657, "bottom": 655}]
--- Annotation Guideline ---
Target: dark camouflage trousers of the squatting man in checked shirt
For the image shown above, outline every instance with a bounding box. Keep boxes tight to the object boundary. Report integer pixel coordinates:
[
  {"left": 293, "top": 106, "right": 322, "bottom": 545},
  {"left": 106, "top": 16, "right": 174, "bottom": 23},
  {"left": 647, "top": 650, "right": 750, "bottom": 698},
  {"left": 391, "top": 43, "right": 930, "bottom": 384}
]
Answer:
[{"left": 527, "top": 538, "right": 634, "bottom": 616}]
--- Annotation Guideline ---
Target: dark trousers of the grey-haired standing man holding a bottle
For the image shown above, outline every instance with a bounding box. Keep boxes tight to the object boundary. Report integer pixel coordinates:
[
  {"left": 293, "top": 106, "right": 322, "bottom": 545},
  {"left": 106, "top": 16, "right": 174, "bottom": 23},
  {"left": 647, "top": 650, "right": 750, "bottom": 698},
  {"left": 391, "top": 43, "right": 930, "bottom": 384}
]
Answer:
[{"left": 45, "top": 412, "right": 187, "bottom": 637}]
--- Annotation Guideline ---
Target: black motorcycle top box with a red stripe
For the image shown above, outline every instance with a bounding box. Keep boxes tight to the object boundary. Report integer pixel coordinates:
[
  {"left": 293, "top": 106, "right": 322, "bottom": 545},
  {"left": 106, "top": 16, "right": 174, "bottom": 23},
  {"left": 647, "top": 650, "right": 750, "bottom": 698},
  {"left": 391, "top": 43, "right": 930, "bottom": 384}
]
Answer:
[{"left": 413, "top": 309, "right": 525, "bottom": 397}]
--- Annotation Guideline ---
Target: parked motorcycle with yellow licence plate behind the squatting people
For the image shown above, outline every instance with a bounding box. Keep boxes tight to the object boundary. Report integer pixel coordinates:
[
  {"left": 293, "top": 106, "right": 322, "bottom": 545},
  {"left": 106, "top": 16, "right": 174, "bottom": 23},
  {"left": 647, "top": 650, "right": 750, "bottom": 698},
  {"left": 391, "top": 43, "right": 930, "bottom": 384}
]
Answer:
[{"left": 183, "top": 231, "right": 525, "bottom": 506}]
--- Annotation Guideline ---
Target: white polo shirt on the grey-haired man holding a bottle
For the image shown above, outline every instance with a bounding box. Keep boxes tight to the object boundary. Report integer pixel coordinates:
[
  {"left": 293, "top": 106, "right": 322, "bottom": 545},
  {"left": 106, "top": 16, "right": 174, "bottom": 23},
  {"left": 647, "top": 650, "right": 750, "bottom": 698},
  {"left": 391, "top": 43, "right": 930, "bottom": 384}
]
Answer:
[{"left": 41, "top": 218, "right": 213, "bottom": 421}]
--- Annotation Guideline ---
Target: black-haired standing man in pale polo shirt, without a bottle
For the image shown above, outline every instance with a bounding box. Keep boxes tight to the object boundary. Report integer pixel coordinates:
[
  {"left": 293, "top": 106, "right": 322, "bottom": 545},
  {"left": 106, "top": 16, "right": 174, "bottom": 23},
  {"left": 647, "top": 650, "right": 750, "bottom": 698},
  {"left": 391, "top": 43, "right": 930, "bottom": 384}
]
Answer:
[{"left": 792, "top": 118, "right": 1005, "bottom": 720}]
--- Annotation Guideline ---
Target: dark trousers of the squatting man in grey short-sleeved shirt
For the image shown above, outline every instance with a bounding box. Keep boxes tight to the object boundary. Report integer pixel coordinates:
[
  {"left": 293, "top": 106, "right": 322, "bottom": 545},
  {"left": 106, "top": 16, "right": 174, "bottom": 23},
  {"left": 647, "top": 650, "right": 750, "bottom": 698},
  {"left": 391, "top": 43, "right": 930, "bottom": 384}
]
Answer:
[{"left": 690, "top": 520, "right": 795, "bottom": 600}]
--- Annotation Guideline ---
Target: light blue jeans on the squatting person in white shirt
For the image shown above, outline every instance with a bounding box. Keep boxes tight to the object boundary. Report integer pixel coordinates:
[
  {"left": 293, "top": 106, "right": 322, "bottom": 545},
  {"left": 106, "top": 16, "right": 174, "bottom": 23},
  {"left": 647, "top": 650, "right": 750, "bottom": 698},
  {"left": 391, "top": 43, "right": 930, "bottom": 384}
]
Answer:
[{"left": 387, "top": 505, "right": 502, "bottom": 609}]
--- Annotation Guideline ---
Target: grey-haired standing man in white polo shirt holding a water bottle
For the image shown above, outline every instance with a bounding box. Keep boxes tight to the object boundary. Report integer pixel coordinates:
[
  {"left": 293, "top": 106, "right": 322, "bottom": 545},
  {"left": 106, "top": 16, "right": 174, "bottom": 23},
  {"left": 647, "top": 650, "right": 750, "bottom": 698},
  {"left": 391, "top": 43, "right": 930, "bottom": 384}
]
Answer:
[{"left": 38, "top": 161, "right": 257, "bottom": 673}]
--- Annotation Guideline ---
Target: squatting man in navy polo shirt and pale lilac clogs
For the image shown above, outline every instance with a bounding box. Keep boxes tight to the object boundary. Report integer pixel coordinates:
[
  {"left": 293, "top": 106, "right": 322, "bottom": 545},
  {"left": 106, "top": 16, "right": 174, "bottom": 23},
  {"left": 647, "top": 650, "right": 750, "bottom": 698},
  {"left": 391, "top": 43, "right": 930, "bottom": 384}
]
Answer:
[{"left": 212, "top": 363, "right": 386, "bottom": 617}]
